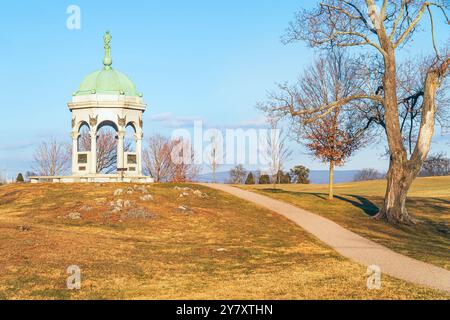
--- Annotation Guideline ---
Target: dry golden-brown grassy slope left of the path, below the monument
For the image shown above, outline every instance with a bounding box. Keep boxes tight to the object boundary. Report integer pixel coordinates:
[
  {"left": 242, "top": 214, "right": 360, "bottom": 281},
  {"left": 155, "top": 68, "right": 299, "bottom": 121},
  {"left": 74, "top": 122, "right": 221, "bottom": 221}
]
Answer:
[{"left": 0, "top": 184, "right": 449, "bottom": 299}]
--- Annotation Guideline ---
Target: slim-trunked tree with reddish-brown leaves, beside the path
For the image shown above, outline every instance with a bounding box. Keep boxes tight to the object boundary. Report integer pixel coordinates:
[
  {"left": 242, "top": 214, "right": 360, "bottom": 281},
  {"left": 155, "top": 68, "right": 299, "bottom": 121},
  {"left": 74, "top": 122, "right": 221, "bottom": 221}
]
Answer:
[{"left": 262, "top": 48, "right": 368, "bottom": 200}]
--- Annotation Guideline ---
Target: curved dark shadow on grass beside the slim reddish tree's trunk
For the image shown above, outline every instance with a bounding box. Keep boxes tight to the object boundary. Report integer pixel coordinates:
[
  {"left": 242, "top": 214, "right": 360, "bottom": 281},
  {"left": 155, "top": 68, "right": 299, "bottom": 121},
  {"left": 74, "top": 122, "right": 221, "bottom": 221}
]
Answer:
[{"left": 263, "top": 189, "right": 379, "bottom": 217}]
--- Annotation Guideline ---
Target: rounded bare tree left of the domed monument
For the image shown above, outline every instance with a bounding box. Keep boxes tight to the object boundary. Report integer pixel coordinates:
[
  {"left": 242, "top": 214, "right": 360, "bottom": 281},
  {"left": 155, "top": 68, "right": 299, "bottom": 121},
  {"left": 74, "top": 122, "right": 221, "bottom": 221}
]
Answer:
[{"left": 33, "top": 139, "right": 71, "bottom": 176}]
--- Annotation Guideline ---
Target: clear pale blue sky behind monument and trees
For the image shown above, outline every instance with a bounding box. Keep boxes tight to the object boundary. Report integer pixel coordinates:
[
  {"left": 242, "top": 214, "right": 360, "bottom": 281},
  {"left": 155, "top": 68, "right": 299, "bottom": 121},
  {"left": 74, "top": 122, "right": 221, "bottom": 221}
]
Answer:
[{"left": 0, "top": 0, "right": 448, "bottom": 175}]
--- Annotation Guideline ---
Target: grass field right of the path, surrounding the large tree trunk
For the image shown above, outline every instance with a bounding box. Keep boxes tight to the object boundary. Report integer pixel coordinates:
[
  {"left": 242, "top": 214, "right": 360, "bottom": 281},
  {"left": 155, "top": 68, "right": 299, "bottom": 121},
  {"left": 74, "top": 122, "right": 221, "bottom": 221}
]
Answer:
[{"left": 245, "top": 177, "right": 450, "bottom": 270}]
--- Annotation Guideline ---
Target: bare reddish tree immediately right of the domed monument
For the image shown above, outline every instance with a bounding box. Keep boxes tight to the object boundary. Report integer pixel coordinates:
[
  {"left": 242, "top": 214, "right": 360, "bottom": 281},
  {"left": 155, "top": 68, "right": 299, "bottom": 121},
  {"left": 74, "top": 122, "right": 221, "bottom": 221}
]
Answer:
[{"left": 142, "top": 135, "right": 172, "bottom": 182}]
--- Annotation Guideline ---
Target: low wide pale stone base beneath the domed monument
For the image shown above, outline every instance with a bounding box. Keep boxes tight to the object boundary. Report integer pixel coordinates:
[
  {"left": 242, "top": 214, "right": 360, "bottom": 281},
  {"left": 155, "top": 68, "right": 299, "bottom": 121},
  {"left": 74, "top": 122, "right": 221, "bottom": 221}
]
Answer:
[{"left": 30, "top": 174, "right": 155, "bottom": 183}]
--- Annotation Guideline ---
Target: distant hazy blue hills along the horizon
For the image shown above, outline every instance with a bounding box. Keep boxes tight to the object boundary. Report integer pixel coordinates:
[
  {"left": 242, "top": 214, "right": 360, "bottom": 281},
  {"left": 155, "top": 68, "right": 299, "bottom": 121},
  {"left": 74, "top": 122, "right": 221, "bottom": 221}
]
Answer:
[{"left": 197, "top": 170, "right": 359, "bottom": 184}]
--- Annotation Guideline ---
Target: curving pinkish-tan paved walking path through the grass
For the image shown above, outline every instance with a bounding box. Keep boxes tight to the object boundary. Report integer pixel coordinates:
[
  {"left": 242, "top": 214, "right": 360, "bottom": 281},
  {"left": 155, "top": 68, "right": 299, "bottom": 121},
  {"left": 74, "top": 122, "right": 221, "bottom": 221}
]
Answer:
[{"left": 202, "top": 184, "right": 450, "bottom": 292}]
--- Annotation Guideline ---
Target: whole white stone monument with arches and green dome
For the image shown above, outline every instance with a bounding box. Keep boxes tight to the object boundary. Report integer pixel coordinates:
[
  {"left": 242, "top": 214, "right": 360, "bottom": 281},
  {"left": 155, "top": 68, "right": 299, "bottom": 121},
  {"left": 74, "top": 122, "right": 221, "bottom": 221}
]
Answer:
[{"left": 33, "top": 32, "right": 153, "bottom": 182}]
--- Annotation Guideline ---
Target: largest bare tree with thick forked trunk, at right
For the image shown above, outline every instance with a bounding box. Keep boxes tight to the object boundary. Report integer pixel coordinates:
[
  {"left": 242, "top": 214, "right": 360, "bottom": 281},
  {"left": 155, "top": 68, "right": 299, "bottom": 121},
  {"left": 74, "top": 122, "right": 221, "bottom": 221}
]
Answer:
[{"left": 268, "top": 0, "right": 450, "bottom": 224}]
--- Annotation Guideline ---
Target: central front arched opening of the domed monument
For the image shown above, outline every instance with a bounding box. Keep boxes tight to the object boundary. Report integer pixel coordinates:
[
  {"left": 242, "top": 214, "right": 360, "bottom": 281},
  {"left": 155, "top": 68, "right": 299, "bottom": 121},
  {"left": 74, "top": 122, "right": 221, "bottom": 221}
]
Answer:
[{"left": 97, "top": 121, "right": 118, "bottom": 174}]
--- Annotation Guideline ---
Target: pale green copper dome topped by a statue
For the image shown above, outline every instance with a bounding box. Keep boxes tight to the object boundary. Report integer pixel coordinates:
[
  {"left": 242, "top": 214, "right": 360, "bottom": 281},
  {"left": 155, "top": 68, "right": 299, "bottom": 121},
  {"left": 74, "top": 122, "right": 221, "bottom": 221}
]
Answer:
[{"left": 73, "top": 32, "right": 142, "bottom": 97}]
